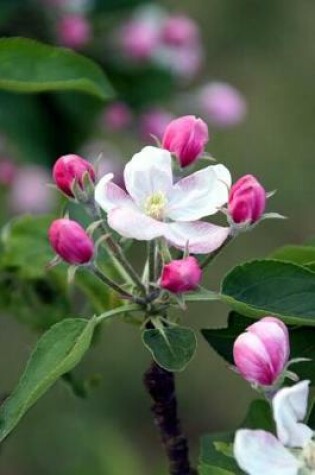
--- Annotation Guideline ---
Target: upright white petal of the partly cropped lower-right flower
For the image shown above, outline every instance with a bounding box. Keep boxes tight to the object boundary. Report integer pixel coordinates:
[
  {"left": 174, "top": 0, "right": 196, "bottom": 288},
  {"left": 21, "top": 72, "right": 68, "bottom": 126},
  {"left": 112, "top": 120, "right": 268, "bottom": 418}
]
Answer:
[{"left": 272, "top": 381, "right": 313, "bottom": 447}]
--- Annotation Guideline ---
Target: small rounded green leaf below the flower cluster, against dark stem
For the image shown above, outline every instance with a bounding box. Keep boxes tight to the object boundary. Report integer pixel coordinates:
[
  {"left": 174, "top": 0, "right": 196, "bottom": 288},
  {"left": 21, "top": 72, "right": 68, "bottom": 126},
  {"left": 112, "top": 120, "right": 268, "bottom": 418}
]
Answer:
[{"left": 142, "top": 327, "right": 197, "bottom": 371}]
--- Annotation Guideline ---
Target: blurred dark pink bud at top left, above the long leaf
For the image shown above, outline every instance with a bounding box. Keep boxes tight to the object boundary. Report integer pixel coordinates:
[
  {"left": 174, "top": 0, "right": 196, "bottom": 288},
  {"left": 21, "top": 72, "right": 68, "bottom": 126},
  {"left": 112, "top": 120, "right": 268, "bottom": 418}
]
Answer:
[{"left": 57, "top": 13, "right": 92, "bottom": 49}]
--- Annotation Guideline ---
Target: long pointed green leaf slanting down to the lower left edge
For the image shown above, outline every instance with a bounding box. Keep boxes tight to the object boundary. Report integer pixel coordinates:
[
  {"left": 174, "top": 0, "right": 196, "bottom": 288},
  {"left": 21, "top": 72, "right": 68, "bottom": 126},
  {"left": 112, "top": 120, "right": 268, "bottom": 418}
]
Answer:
[{"left": 0, "top": 318, "right": 96, "bottom": 441}]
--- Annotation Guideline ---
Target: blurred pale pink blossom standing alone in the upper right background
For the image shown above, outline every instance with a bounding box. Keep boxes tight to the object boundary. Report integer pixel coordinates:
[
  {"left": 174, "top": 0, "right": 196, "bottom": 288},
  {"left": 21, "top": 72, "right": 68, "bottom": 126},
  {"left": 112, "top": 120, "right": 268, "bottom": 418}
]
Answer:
[{"left": 197, "top": 82, "right": 247, "bottom": 127}]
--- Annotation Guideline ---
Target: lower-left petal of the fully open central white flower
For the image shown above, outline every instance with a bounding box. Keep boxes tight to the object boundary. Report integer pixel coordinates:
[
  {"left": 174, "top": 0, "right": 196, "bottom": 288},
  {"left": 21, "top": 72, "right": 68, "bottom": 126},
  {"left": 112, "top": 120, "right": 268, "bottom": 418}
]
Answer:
[{"left": 108, "top": 208, "right": 165, "bottom": 241}]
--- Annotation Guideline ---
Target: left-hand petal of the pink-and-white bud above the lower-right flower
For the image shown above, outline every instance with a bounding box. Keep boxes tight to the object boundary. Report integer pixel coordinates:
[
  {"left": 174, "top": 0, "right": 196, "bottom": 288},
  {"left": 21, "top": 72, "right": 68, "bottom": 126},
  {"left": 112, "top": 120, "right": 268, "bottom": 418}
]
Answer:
[{"left": 233, "top": 332, "right": 275, "bottom": 386}]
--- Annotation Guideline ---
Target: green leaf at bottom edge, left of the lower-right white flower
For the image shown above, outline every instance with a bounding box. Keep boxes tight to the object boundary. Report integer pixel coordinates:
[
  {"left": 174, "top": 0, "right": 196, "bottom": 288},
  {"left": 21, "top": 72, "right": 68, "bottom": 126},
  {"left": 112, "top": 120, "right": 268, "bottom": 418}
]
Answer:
[{"left": 199, "top": 432, "right": 243, "bottom": 475}]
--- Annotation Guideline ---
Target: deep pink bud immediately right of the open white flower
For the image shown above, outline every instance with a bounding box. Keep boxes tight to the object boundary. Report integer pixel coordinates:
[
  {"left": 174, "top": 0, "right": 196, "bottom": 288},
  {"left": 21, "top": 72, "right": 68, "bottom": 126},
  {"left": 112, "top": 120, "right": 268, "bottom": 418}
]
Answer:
[{"left": 228, "top": 175, "right": 267, "bottom": 224}]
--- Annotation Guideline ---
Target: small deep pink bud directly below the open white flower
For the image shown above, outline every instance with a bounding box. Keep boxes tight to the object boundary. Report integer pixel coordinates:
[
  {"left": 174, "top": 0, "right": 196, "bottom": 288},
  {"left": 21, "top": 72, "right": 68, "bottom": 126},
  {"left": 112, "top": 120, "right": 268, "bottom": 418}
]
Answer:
[{"left": 160, "top": 256, "right": 202, "bottom": 294}]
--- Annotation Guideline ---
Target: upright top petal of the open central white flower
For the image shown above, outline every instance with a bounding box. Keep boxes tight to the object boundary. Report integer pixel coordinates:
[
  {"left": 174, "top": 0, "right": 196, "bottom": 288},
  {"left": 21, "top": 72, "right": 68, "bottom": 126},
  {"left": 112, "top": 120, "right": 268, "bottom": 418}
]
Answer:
[{"left": 124, "top": 147, "right": 173, "bottom": 207}]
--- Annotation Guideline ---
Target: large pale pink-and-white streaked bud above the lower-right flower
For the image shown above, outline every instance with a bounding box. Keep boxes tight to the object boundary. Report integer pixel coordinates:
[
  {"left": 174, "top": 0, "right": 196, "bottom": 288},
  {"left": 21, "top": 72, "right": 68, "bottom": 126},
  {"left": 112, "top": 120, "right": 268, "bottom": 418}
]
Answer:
[{"left": 233, "top": 317, "right": 290, "bottom": 386}]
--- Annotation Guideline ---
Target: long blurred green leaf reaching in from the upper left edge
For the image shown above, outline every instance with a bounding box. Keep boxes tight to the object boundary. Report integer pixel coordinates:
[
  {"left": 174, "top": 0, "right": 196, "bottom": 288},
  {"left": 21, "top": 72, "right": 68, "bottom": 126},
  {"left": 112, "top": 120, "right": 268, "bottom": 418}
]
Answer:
[{"left": 0, "top": 38, "right": 113, "bottom": 100}]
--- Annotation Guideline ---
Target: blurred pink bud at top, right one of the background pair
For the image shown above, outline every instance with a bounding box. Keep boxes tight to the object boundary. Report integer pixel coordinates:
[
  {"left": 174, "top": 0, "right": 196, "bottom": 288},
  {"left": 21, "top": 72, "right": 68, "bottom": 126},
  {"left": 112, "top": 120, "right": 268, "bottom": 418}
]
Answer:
[{"left": 161, "top": 15, "right": 199, "bottom": 46}]
